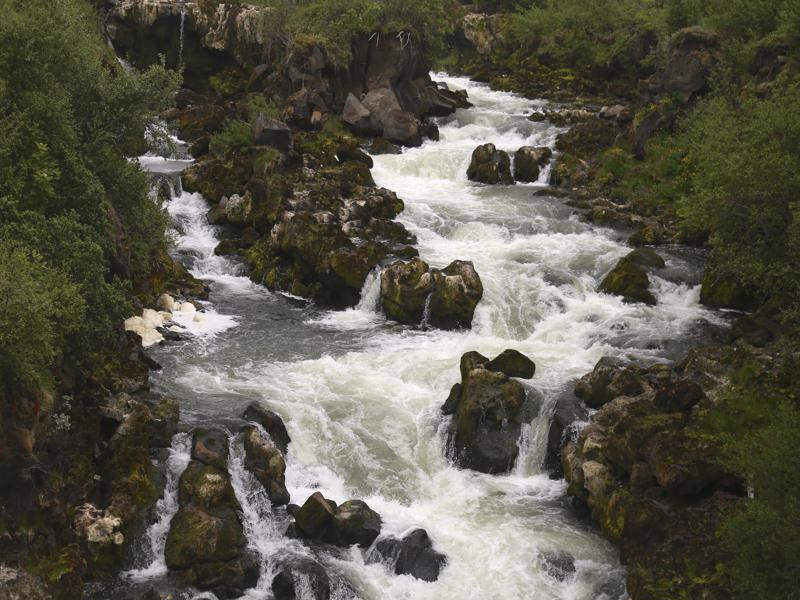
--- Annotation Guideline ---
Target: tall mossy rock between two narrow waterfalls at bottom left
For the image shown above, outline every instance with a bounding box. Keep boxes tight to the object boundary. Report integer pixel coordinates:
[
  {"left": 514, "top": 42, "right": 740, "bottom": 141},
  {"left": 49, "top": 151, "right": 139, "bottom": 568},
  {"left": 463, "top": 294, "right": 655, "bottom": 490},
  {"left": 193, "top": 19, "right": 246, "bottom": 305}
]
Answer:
[{"left": 164, "top": 429, "right": 259, "bottom": 598}]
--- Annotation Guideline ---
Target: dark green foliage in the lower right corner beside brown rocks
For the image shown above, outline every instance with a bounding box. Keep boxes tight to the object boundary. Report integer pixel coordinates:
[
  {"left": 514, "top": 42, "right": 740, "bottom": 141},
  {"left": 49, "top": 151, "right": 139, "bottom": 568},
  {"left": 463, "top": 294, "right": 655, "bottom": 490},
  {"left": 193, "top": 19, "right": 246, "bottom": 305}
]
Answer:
[{"left": 707, "top": 352, "right": 800, "bottom": 600}]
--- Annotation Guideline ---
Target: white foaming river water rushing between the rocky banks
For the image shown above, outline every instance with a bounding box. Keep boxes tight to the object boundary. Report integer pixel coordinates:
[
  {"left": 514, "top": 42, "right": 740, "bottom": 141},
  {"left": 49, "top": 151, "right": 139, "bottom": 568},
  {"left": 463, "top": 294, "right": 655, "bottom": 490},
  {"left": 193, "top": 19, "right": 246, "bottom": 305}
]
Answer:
[{"left": 98, "top": 75, "right": 719, "bottom": 600}]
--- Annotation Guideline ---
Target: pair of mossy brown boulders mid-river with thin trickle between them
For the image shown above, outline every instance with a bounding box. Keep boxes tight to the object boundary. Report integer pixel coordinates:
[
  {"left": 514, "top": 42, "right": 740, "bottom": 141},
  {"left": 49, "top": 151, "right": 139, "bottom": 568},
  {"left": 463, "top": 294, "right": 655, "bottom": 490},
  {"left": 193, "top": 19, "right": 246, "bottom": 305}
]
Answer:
[{"left": 380, "top": 258, "right": 483, "bottom": 329}]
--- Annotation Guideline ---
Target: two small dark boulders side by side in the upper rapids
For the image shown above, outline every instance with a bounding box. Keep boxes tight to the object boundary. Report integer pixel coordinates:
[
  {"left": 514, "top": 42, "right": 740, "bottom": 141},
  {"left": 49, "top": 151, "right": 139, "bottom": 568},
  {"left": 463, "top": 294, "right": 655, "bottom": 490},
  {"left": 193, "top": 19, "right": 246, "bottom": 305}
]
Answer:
[{"left": 467, "top": 143, "right": 553, "bottom": 185}]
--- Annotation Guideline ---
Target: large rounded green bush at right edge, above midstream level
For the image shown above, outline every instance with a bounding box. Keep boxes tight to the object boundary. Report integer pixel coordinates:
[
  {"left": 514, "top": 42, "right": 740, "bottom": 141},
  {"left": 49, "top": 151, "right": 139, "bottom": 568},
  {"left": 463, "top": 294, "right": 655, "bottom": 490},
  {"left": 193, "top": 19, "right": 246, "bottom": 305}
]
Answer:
[{"left": 681, "top": 87, "right": 800, "bottom": 293}]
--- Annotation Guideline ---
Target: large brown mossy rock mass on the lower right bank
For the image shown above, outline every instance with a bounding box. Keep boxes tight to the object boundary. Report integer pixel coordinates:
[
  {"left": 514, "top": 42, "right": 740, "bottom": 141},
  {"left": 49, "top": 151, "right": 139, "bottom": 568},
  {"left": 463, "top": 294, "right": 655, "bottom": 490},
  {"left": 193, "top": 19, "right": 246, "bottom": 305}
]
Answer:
[{"left": 561, "top": 348, "right": 743, "bottom": 597}]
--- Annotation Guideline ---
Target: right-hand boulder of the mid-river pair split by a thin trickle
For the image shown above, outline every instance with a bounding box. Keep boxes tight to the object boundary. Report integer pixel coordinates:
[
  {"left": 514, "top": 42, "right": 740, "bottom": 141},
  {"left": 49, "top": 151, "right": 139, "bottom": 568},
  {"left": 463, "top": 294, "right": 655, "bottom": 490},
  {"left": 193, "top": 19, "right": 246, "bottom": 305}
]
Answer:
[{"left": 429, "top": 260, "right": 483, "bottom": 329}]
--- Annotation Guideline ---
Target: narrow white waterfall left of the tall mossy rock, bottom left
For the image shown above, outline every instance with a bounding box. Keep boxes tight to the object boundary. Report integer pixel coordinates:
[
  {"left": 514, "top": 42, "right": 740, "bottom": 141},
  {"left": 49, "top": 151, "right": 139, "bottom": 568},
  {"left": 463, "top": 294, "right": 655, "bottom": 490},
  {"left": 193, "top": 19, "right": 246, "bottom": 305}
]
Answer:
[{"left": 123, "top": 433, "right": 192, "bottom": 581}]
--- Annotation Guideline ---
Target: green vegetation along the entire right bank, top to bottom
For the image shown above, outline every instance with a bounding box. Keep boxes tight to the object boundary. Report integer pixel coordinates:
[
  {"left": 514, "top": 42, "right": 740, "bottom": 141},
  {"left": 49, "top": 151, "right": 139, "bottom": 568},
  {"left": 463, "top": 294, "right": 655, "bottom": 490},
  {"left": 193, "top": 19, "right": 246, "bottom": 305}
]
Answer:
[{"left": 450, "top": 0, "right": 800, "bottom": 600}]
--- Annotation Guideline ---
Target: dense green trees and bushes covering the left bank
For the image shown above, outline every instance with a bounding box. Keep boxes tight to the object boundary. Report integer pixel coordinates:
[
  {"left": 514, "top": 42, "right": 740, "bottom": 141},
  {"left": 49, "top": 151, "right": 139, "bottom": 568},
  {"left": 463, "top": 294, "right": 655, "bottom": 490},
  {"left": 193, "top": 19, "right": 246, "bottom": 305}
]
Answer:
[{"left": 0, "top": 0, "right": 179, "bottom": 384}]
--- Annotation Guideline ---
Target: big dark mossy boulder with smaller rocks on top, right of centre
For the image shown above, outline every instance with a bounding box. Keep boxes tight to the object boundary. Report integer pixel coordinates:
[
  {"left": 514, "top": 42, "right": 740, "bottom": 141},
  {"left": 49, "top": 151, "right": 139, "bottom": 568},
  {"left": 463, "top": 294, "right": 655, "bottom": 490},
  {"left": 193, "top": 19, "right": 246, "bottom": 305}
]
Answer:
[{"left": 442, "top": 350, "right": 539, "bottom": 473}]
